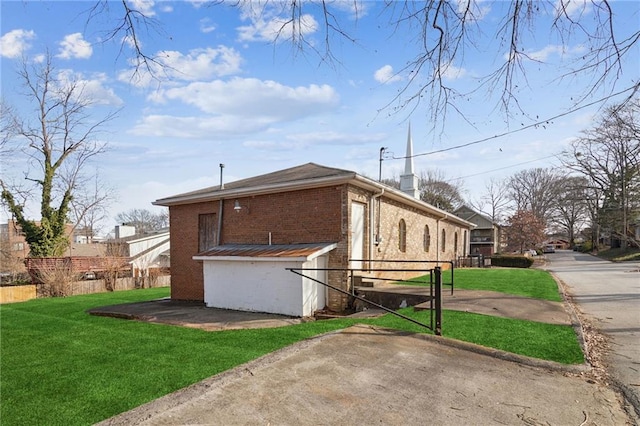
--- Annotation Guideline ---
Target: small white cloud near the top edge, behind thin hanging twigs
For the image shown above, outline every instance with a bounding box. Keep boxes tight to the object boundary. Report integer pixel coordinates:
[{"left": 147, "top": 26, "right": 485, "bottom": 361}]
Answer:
[{"left": 237, "top": 10, "right": 318, "bottom": 42}]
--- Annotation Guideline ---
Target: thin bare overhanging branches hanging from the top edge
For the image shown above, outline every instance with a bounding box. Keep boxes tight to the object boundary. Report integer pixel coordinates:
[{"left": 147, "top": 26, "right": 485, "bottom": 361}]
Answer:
[{"left": 89, "top": 0, "right": 640, "bottom": 122}]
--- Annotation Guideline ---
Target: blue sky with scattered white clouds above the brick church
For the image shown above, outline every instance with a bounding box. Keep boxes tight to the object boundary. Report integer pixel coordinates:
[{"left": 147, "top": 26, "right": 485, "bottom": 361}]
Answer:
[{"left": 0, "top": 1, "right": 640, "bottom": 235}]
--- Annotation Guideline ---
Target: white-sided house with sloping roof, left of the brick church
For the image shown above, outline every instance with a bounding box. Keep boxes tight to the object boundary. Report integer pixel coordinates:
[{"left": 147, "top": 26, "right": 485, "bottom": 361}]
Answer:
[{"left": 107, "top": 225, "right": 170, "bottom": 277}]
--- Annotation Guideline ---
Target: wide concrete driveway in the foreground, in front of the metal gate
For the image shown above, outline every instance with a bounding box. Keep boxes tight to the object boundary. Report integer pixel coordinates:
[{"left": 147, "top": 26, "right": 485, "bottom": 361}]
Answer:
[{"left": 101, "top": 326, "right": 635, "bottom": 426}]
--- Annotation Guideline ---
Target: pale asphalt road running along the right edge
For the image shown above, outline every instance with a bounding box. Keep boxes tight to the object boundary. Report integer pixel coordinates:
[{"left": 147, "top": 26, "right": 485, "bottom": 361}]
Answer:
[{"left": 545, "top": 250, "right": 640, "bottom": 416}]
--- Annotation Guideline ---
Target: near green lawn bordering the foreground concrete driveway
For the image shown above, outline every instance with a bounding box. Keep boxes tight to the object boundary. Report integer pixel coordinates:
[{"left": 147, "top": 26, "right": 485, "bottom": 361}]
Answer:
[{"left": 0, "top": 276, "right": 583, "bottom": 425}]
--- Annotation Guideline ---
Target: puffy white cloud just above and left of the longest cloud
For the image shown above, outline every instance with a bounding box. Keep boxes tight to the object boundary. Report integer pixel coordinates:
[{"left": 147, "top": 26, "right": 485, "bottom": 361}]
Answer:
[{"left": 118, "top": 46, "right": 242, "bottom": 87}]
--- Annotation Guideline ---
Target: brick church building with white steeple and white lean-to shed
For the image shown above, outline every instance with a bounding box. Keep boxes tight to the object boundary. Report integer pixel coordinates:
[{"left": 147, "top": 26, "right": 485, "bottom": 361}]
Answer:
[{"left": 153, "top": 139, "right": 473, "bottom": 316}]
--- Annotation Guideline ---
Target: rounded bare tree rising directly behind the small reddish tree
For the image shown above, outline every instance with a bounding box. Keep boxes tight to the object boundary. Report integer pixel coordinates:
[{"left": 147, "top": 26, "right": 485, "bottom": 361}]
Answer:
[{"left": 508, "top": 168, "right": 563, "bottom": 223}]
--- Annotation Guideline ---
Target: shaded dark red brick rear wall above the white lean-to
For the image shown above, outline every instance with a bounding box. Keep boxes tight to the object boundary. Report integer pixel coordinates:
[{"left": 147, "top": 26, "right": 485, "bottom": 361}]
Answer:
[{"left": 169, "top": 186, "right": 345, "bottom": 301}]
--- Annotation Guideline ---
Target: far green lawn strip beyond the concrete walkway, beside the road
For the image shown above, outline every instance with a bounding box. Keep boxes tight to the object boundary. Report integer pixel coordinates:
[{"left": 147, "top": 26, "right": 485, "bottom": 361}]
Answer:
[{"left": 401, "top": 268, "right": 562, "bottom": 302}]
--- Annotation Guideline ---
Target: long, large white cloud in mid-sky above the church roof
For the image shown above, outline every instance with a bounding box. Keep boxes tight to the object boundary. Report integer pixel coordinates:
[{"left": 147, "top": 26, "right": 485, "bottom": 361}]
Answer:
[{"left": 158, "top": 77, "right": 339, "bottom": 121}]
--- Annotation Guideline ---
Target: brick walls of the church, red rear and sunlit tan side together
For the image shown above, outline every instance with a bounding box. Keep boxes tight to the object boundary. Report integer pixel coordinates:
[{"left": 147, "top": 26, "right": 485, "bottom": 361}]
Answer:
[{"left": 169, "top": 185, "right": 464, "bottom": 311}]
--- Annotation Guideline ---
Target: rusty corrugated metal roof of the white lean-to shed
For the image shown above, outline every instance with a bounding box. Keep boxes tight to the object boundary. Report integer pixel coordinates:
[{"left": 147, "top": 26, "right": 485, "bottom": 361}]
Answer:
[{"left": 196, "top": 243, "right": 334, "bottom": 257}]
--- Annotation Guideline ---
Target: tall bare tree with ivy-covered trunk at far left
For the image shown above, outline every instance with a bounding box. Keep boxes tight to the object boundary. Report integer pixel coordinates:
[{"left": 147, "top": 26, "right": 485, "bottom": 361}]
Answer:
[{"left": 0, "top": 55, "right": 114, "bottom": 257}]
